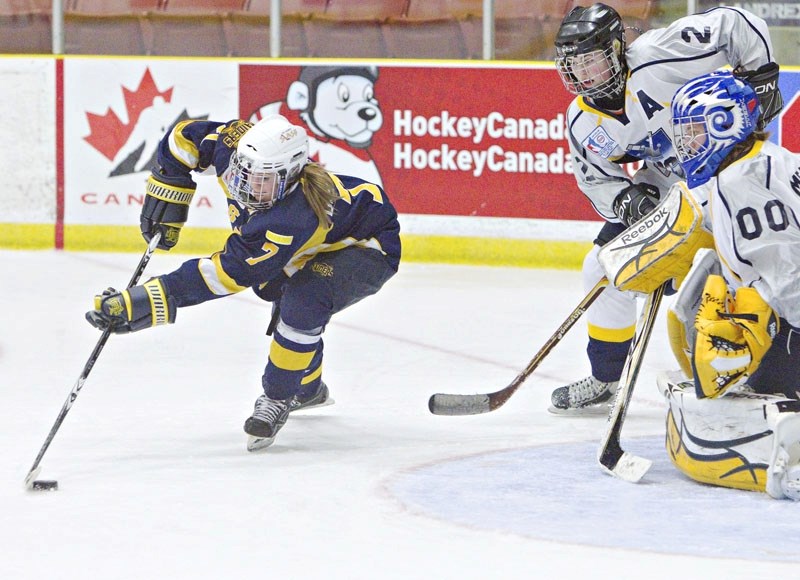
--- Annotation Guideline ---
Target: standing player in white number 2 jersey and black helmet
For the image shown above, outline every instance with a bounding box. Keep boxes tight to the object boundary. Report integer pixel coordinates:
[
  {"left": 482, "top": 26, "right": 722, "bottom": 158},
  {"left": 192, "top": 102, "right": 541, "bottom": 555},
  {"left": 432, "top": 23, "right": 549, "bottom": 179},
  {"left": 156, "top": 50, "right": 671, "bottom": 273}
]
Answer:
[{"left": 550, "top": 4, "right": 782, "bottom": 413}]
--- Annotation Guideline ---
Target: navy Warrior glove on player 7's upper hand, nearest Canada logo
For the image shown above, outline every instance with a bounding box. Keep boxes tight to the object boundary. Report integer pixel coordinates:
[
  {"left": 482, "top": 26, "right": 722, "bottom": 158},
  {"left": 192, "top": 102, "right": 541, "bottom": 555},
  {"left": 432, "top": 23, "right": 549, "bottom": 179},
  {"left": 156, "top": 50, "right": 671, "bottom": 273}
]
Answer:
[{"left": 139, "top": 175, "right": 196, "bottom": 250}]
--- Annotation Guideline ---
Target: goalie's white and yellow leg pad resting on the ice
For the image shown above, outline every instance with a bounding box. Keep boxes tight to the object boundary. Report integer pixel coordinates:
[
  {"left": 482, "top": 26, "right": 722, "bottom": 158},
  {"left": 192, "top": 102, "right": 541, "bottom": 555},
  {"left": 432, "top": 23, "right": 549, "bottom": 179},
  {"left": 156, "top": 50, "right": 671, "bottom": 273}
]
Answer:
[{"left": 658, "top": 372, "right": 800, "bottom": 501}]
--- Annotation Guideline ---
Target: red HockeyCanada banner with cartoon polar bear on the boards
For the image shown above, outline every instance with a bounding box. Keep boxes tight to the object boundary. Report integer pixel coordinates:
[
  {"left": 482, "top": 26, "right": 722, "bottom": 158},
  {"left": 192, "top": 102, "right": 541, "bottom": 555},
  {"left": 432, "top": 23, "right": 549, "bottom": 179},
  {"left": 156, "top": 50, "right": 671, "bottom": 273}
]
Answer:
[{"left": 239, "top": 64, "right": 598, "bottom": 220}]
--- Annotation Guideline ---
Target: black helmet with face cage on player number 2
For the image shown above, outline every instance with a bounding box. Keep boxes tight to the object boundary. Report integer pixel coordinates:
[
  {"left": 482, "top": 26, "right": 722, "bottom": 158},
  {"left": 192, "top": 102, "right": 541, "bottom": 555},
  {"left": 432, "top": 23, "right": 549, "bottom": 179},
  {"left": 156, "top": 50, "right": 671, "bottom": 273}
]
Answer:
[{"left": 555, "top": 3, "right": 627, "bottom": 101}]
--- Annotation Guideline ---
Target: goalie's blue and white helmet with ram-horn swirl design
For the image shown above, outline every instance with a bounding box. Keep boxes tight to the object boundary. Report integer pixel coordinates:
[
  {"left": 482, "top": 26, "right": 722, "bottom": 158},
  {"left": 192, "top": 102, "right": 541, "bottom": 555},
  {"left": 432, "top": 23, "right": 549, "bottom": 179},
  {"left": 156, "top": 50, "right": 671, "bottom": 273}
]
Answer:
[{"left": 672, "top": 72, "right": 759, "bottom": 187}]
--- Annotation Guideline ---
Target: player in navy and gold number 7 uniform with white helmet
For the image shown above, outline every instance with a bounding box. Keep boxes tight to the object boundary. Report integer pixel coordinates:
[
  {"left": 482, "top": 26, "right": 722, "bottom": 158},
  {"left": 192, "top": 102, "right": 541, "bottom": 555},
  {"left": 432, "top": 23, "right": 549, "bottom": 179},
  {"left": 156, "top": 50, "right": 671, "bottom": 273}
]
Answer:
[{"left": 86, "top": 115, "right": 400, "bottom": 451}]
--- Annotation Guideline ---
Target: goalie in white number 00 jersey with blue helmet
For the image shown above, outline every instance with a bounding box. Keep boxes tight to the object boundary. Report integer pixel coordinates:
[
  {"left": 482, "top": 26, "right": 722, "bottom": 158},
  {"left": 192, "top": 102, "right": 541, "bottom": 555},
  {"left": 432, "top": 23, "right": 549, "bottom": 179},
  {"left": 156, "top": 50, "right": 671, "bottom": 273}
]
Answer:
[{"left": 659, "top": 72, "right": 800, "bottom": 500}]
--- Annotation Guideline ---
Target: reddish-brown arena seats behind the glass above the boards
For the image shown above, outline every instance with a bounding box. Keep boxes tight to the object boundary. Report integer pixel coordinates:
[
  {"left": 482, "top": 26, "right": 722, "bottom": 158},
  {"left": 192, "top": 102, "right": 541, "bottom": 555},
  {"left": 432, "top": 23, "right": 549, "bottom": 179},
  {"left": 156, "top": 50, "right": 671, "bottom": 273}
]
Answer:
[{"left": 0, "top": 0, "right": 656, "bottom": 60}]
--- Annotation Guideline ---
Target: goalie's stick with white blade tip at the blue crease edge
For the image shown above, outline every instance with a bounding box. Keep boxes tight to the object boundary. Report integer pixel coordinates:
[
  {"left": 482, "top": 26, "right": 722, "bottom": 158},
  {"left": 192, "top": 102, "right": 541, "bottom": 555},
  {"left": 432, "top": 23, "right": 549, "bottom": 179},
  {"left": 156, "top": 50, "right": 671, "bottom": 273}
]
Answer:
[{"left": 597, "top": 280, "right": 671, "bottom": 483}]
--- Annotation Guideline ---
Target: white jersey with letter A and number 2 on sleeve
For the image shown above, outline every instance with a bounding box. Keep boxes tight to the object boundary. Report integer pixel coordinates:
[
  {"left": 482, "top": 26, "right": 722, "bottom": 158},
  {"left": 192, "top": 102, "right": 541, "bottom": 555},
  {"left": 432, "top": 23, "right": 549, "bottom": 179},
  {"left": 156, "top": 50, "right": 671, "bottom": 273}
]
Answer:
[{"left": 567, "top": 7, "right": 774, "bottom": 222}]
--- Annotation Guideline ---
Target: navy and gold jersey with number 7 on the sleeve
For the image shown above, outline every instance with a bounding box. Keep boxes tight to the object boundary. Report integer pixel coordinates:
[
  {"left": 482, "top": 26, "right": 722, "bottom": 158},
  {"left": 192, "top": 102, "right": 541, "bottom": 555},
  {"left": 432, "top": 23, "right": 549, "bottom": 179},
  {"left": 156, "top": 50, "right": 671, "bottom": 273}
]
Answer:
[{"left": 152, "top": 120, "right": 400, "bottom": 307}]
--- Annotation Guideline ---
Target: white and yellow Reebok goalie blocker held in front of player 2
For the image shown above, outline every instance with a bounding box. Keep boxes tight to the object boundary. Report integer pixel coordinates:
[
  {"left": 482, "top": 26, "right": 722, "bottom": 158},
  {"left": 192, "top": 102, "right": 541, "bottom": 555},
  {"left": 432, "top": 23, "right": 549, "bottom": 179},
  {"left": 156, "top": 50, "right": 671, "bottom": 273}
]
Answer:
[{"left": 598, "top": 182, "right": 714, "bottom": 294}]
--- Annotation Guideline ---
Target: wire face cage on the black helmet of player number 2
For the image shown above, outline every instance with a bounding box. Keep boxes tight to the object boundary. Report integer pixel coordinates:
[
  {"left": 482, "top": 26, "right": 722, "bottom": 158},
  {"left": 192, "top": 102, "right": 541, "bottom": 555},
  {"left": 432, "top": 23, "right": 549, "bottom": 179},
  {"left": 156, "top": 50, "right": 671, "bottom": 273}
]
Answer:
[{"left": 556, "top": 42, "right": 625, "bottom": 99}]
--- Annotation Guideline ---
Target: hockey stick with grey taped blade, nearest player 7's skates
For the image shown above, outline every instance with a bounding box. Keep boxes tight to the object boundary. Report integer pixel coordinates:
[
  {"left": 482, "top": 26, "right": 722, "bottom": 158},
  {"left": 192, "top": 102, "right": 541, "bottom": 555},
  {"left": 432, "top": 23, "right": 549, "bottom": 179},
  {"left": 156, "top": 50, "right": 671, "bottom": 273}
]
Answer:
[{"left": 428, "top": 277, "right": 608, "bottom": 415}]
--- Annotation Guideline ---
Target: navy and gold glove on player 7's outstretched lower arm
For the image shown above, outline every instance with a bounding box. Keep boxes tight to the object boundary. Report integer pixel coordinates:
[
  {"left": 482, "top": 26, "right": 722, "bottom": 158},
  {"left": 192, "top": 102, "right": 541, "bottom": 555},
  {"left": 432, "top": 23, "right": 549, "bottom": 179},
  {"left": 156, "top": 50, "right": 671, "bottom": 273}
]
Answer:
[{"left": 86, "top": 278, "right": 176, "bottom": 334}]
